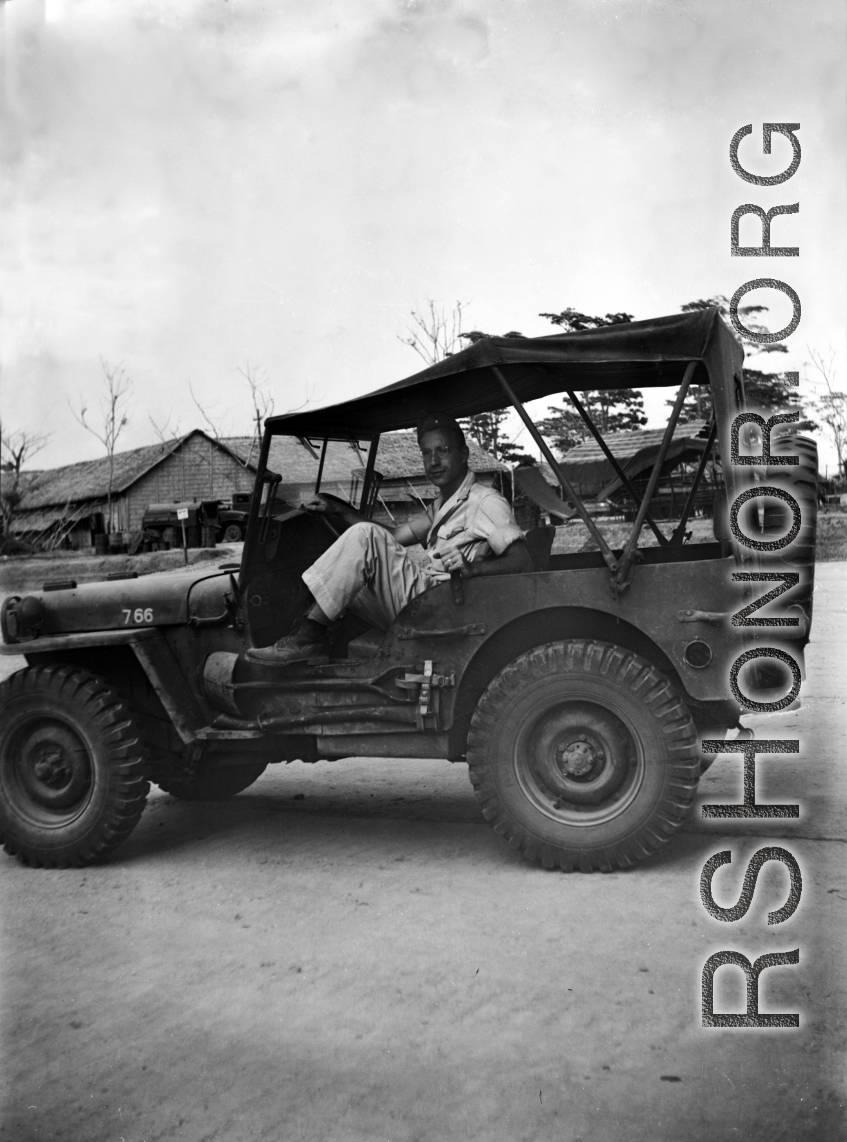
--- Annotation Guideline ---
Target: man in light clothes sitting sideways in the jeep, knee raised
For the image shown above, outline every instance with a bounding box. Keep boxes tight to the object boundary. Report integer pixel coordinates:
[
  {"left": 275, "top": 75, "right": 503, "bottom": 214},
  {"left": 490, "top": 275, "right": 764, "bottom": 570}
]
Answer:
[{"left": 247, "top": 412, "right": 532, "bottom": 666}]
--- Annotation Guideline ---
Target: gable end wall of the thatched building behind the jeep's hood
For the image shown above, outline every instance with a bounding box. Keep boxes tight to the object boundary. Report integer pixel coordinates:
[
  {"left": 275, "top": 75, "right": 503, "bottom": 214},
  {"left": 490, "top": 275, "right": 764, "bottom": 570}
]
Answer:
[{"left": 119, "top": 436, "right": 256, "bottom": 531}]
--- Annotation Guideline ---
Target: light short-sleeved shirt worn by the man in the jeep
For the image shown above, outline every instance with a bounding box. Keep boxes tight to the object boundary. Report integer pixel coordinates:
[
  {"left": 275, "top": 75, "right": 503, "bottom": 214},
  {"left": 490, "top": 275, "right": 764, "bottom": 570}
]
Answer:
[{"left": 424, "top": 472, "right": 524, "bottom": 579}]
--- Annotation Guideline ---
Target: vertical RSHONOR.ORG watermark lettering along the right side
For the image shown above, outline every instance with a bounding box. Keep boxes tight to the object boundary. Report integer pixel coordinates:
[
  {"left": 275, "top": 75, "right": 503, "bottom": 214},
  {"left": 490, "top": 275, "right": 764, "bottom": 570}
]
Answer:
[{"left": 700, "top": 123, "right": 808, "bottom": 1028}]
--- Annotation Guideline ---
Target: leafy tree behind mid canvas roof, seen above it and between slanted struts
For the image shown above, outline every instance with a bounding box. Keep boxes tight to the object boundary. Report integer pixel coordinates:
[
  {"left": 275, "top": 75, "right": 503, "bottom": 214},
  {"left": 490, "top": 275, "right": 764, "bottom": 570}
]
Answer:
[{"left": 538, "top": 307, "right": 647, "bottom": 452}]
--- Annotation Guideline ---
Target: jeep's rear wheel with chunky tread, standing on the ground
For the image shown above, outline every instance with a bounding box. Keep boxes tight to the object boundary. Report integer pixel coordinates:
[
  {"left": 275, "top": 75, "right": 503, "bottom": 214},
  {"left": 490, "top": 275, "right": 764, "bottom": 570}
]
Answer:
[{"left": 468, "top": 640, "right": 700, "bottom": 872}]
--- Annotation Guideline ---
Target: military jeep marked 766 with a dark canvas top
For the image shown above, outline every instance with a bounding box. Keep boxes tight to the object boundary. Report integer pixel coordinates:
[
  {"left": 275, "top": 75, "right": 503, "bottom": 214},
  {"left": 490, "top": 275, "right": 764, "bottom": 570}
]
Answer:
[{"left": 0, "top": 309, "right": 817, "bottom": 871}]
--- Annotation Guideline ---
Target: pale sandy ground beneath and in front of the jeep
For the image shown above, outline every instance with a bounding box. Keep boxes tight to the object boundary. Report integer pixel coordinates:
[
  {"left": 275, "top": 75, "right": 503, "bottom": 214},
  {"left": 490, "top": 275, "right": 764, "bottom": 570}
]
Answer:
[{"left": 0, "top": 563, "right": 847, "bottom": 1142}]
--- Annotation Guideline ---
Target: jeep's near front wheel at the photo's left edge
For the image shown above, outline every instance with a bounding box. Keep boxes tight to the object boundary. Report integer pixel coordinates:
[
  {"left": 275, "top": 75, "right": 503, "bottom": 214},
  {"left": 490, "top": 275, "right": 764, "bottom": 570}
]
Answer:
[{"left": 0, "top": 665, "right": 150, "bottom": 868}]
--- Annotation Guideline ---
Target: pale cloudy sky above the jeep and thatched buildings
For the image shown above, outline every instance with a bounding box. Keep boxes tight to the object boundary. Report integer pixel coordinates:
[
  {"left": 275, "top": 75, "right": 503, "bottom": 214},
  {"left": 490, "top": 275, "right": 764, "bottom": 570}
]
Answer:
[{"left": 0, "top": 0, "right": 847, "bottom": 467}]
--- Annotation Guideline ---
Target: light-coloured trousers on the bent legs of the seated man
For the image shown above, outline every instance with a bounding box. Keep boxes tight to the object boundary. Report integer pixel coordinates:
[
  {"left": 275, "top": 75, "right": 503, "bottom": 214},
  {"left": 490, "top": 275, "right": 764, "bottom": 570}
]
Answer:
[{"left": 303, "top": 523, "right": 436, "bottom": 630}]
